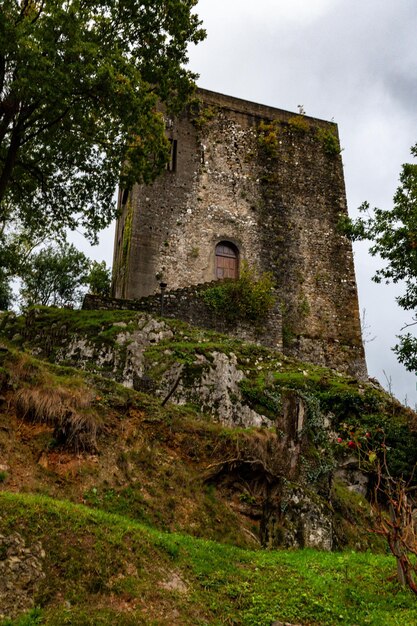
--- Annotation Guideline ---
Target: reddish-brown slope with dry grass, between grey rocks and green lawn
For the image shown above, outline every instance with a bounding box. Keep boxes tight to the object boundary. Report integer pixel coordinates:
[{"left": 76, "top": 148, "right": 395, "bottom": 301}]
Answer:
[{"left": 0, "top": 338, "right": 256, "bottom": 546}]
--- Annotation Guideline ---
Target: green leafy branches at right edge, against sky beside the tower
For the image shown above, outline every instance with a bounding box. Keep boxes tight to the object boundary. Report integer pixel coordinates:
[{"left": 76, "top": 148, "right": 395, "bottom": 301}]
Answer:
[{"left": 342, "top": 144, "right": 417, "bottom": 371}]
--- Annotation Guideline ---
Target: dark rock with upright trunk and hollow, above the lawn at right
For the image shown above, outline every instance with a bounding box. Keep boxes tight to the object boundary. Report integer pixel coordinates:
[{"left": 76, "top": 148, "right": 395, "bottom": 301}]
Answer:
[{"left": 203, "top": 391, "right": 333, "bottom": 550}]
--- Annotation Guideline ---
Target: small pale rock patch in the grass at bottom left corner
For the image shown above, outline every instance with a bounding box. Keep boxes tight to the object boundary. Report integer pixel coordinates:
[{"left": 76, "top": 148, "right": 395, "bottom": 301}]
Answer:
[{"left": 0, "top": 533, "right": 45, "bottom": 619}]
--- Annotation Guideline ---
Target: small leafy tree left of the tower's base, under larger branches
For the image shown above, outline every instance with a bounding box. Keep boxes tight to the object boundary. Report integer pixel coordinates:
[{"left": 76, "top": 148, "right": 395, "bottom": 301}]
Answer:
[{"left": 20, "top": 244, "right": 90, "bottom": 307}]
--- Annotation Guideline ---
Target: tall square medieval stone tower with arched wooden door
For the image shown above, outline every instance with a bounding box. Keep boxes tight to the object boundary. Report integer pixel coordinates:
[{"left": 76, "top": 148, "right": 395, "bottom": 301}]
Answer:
[{"left": 113, "top": 85, "right": 366, "bottom": 376}]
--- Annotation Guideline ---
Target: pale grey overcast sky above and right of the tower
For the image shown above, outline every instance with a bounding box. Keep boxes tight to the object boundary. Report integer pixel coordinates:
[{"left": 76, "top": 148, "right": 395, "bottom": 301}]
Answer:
[{"left": 90, "top": 0, "right": 417, "bottom": 406}]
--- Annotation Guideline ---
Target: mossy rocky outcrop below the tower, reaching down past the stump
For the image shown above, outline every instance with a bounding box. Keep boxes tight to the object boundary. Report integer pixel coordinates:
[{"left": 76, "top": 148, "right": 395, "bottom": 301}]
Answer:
[{"left": 0, "top": 309, "right": 382, "bottom": 550}]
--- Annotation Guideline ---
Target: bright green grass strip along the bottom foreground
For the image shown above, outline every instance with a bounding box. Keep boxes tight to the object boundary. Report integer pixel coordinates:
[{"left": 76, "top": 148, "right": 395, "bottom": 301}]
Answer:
[{"left": 0, "top": 493, "right": 417, "bottom": 626}]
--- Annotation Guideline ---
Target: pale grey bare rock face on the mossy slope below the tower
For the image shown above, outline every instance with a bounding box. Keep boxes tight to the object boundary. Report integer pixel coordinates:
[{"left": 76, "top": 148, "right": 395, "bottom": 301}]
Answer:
[{"left": 52, "top": 315, "right": 272, "bottom": 428}]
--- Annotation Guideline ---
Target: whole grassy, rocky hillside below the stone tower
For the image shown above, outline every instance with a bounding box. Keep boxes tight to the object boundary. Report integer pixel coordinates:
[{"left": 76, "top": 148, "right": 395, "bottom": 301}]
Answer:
[{"left": 0, "top": 309, "right": 417, "bottom": 626}]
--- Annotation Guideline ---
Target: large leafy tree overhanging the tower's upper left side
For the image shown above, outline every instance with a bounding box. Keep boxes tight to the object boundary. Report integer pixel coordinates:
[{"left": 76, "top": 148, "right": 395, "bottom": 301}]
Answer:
[{"left": 0, "top": 0, "right": 204, "bottom": 245}]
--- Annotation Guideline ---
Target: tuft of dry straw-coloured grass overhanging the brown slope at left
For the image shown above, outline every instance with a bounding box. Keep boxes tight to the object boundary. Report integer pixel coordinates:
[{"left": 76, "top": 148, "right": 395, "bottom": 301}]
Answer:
[{"left": 15, "top": 387, "right": 100, "bottom": 452}]
